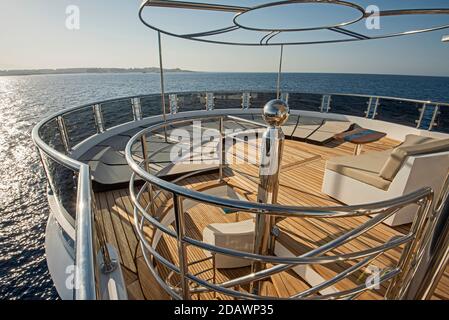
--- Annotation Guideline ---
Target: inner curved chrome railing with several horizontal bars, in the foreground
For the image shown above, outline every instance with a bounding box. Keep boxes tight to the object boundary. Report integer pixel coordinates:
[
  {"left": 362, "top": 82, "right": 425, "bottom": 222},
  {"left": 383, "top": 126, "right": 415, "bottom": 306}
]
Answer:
[{"left": 126, "top": 116, "right": 433, "bottom": 299}]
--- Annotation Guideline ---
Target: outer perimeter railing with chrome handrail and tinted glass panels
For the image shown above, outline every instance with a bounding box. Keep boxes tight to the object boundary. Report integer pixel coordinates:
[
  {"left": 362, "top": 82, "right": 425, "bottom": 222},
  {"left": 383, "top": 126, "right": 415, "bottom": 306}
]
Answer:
[{"left": 32, "top": 92, "right": 449, "bottom": 300}]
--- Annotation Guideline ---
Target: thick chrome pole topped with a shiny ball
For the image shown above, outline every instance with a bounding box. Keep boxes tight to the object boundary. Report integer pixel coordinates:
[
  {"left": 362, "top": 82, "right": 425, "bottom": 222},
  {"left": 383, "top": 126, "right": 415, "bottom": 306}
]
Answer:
[{"left": 250, "top": 100, "right": 290, "bottom": 294}]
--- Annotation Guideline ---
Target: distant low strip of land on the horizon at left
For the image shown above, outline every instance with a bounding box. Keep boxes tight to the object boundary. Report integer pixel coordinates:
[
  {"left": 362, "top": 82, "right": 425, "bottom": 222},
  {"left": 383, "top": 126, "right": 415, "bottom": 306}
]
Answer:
[{"left": 0, "top": 67, "right": 194, "bottom": 76}]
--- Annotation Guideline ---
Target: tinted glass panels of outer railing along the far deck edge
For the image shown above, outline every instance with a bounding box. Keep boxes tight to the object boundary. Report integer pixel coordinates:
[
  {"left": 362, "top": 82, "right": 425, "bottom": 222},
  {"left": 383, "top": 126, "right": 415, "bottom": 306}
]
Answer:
[{"left": 36, "top": 91, "right": 449, "bottom": 153}]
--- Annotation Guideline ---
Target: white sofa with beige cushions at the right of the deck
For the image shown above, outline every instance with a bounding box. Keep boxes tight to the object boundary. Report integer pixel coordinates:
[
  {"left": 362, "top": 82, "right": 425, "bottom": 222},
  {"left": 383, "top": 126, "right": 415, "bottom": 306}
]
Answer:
[{"left": 322, "top": 134, "right": 449, "bottom": 226}]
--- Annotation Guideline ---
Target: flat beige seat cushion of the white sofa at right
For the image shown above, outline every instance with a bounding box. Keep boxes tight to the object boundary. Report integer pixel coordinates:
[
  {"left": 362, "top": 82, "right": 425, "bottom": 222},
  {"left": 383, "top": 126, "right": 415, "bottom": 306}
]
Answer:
[{"left": 326, "top": 150, "right": 391, "bottom": 190}]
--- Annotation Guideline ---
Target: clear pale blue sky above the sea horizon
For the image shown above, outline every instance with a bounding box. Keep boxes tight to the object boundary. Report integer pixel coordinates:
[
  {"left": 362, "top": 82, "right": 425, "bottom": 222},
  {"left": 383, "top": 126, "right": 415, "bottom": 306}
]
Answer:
[{"left": 0, "top": 0, "right": 449, "bottom": 76}]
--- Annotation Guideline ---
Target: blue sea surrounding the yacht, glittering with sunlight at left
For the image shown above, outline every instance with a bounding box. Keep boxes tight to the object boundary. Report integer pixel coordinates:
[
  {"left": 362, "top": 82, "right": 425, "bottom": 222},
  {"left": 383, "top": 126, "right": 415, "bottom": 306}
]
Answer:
[{"left": 0, "top": 73, "right": 449, "bottom": 299}]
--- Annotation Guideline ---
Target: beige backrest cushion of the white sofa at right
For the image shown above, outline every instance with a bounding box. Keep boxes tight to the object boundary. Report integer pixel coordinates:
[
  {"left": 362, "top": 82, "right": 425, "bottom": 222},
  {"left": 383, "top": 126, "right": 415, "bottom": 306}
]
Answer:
[{"left": 379, "top": 135, "right": 449, "bottom": 181}]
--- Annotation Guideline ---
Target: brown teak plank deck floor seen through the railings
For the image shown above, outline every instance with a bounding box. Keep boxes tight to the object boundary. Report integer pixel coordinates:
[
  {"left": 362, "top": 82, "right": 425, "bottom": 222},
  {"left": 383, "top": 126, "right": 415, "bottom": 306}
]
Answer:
[{"left": 95, "top": 138, "right": 449, "bottom": 299}]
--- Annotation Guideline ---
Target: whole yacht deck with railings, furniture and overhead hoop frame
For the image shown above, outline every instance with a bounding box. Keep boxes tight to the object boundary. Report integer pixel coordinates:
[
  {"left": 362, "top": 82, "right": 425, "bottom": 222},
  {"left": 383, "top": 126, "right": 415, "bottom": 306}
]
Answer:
[{"left": 32, "top": 1, "right": 449, "bottom": 300}]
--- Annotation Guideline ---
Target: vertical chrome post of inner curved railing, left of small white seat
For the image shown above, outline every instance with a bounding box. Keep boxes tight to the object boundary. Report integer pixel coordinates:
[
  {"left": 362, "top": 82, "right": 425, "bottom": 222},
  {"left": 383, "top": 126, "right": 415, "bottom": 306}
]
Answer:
[{"left": 173, "top": 193, "right": 190, "bottom": 300}]
